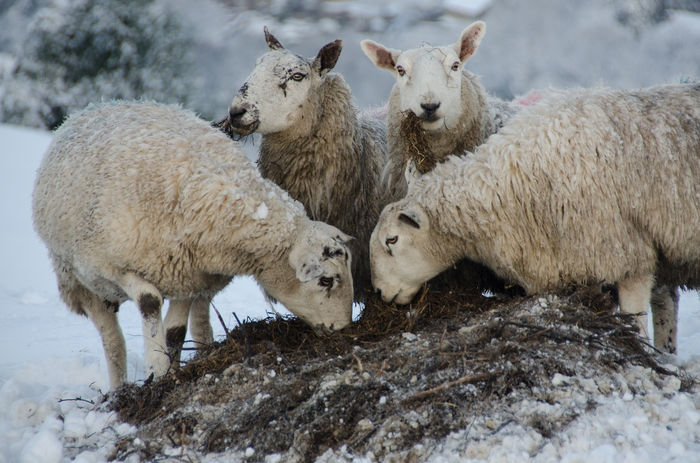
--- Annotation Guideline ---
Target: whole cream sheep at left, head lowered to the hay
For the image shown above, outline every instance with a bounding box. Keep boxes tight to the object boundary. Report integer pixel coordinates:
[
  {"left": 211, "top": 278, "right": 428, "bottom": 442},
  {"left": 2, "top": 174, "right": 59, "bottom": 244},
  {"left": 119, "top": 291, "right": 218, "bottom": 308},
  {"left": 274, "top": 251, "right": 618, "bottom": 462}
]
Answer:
[{"left": 33, "top": 102, "right": 353, "bottom": 388}]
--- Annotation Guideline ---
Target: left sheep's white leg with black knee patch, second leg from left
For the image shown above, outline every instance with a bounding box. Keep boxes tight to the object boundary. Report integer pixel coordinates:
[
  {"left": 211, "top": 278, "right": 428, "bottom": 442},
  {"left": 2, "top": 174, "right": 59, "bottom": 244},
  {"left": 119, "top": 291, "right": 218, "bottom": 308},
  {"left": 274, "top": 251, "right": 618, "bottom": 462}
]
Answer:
[{"left": 119, "top": 273, "right": 170, "bottom": 377}]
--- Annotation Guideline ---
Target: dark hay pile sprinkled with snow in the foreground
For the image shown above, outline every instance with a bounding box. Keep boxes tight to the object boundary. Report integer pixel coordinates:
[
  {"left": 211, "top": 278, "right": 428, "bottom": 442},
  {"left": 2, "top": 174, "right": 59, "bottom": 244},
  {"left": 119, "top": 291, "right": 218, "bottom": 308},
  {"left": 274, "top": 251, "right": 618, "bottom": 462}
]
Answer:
[{"left": 108, "top": 290, "right": 692, "bottom": 461}]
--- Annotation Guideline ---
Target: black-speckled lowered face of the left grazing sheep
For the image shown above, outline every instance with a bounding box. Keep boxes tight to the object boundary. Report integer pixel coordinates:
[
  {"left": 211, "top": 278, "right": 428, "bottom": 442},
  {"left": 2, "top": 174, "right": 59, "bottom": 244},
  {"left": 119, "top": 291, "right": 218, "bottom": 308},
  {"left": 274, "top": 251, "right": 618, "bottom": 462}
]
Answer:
[{"left": 261, "top": 220, "right": 353, "bottom": 333}]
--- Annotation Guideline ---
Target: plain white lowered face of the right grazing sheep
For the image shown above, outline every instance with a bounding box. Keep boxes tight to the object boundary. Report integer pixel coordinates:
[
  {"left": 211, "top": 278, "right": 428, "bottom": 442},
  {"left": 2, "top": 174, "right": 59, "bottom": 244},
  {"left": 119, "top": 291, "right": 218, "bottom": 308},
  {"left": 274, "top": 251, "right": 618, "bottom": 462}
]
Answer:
[{"left": 370, "top": 200, "right": 447, "bottom": 304}]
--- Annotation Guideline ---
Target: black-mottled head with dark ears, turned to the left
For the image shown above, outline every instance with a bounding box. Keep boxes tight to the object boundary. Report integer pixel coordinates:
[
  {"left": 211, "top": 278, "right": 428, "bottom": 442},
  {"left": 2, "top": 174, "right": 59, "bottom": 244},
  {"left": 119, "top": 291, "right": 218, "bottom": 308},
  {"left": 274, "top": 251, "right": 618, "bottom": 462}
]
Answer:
[{"left": 229, "top": 28, "right": 342, "bottom": 135}]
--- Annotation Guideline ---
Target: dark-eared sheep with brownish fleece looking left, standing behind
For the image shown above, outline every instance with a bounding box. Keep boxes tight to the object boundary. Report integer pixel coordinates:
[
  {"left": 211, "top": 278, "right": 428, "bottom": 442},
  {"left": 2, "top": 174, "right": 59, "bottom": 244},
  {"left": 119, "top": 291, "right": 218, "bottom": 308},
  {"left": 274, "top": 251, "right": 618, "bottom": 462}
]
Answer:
[{"left": 227, "top": 27, "right": 387, "bottom": 300}]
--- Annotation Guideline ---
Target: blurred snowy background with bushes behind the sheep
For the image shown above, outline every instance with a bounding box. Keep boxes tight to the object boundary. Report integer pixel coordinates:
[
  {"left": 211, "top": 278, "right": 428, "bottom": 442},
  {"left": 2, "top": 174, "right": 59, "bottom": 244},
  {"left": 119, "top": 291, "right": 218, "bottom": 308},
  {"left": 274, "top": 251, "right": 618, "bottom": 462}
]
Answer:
[{"left": 0, "top": 0, "right": 700, "bottom": 129}]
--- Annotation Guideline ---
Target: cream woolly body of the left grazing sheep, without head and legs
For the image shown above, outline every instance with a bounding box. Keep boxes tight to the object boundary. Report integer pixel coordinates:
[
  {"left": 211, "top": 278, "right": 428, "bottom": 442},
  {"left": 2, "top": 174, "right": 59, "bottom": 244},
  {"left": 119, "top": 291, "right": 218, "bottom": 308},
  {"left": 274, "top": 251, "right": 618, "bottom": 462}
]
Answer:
[{"left": 33, "top": 102, "right": 303, "bottom": 302}]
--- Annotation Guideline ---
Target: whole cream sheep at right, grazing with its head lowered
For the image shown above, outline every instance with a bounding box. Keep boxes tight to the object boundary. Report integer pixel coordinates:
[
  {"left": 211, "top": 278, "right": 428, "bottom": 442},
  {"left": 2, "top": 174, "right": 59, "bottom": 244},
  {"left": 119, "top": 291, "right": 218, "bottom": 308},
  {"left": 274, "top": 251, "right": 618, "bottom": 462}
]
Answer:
[{"left": 370, "top": 84, "right": 700, "bottom": 352}]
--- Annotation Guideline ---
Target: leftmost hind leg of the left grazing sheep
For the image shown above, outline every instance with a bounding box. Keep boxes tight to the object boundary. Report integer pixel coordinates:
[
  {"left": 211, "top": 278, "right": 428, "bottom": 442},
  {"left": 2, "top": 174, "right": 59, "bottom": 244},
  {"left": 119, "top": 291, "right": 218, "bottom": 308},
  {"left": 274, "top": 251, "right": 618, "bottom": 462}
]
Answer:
[{"left": 54, "top": 264, "right": 126, "bottom": 389}]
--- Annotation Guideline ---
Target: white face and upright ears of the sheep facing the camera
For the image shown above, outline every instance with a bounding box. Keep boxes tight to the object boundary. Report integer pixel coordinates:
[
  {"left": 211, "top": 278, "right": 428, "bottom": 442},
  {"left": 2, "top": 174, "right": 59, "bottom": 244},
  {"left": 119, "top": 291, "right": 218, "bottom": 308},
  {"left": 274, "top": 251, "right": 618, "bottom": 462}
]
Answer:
[{"left": 361, "top": 21, "right": 486, "bottom": 131}]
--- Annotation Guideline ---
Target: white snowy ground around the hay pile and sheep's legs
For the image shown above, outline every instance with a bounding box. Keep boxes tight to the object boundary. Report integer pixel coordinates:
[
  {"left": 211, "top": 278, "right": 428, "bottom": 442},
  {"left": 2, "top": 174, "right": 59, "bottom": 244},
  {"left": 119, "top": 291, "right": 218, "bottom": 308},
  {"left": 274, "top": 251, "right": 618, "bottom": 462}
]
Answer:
[{"left": 0, "top": 121, "right": 700, "bottom": 463}]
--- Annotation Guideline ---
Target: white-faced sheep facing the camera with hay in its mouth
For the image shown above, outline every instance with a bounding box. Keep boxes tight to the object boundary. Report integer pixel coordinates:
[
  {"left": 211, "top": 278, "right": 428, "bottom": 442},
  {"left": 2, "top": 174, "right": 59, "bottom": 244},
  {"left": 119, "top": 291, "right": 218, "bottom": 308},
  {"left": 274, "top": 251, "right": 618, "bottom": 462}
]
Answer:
[{"left": 360, "top": 21, "right": 518, "bottom": 200}]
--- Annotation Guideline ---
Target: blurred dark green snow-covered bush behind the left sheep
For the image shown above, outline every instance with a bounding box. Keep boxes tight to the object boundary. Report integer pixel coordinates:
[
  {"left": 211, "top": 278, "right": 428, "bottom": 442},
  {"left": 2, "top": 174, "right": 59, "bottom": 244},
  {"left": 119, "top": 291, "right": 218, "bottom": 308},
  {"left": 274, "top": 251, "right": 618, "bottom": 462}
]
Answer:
[{"left": 0, "top": 0, "right": 197, "bottom": 128}]
